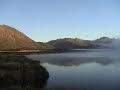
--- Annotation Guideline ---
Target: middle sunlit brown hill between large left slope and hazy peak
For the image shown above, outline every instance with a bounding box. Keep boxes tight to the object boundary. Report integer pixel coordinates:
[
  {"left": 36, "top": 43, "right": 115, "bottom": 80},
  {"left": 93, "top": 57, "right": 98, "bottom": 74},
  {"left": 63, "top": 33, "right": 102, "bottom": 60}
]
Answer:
[{"left": 48, "top": 38, "right": 97, "bottom": 49}]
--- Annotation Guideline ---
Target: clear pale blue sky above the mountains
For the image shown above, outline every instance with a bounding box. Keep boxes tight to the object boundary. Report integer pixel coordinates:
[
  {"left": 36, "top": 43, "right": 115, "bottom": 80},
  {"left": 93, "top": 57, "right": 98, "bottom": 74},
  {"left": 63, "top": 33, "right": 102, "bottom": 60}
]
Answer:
[{"left": 0, "top": 0, "right": 120, "bottom": 42}]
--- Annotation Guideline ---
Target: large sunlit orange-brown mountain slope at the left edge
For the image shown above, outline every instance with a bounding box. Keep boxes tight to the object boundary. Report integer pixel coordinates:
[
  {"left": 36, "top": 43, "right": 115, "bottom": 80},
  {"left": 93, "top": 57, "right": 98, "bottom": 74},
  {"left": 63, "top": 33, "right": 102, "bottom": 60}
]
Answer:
[{"left": 0, "top": 25, "right": 38, "bottom": 51}]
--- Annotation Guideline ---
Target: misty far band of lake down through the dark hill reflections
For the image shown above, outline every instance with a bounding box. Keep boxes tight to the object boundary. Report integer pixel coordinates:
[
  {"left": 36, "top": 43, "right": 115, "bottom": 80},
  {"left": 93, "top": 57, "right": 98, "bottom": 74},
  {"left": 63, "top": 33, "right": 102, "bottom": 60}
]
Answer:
[{"left": 28, "top": 49, "right": 120, "bottom": 66}]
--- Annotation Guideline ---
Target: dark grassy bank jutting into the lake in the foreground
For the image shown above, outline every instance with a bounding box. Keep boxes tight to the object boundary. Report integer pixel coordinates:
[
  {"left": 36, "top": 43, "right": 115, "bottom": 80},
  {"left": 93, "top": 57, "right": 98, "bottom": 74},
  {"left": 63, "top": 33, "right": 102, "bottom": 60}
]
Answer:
[{"left": 0, "top": 53, "right": 49, "bottom": 89}]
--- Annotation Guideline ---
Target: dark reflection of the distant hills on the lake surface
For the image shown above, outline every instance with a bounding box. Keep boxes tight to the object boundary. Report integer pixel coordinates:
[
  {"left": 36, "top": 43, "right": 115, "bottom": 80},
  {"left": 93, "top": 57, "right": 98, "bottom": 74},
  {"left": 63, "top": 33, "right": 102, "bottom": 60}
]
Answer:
[{"left": 41, "top": 57, "right": 113, "bottom": 66}]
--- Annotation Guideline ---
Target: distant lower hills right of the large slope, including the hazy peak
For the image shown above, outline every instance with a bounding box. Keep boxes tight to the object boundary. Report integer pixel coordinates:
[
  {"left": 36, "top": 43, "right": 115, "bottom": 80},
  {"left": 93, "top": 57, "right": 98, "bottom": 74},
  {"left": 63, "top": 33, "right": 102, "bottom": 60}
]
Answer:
[{"left": 48, "top": 37, "right": 113, "bottom": 49}]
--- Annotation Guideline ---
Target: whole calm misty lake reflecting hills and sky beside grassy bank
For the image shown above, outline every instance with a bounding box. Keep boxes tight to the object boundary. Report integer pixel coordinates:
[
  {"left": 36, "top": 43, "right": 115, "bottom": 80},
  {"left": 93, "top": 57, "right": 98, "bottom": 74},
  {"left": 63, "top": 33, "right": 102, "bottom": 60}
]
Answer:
[{"left": 27, "top": 49, "right": 120, "bottom": 90}]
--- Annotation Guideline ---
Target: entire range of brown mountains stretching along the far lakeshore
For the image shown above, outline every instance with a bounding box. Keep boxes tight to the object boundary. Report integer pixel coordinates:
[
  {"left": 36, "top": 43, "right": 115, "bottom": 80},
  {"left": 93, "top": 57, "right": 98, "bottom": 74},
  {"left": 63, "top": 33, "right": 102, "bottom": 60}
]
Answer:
[{"left": 0, "top": 25, "right": 113, "bottom": 51}]
